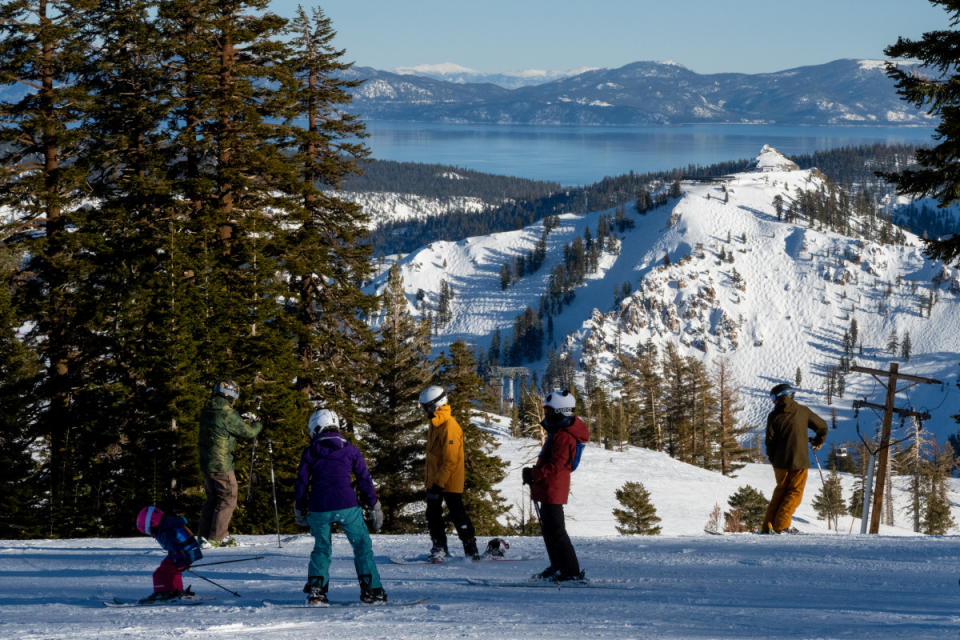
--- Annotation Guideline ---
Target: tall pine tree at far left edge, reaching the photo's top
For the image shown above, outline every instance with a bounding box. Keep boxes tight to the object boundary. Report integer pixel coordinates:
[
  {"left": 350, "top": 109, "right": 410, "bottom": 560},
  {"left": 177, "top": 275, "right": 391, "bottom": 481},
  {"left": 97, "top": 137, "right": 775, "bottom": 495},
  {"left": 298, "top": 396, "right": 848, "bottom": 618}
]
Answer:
[{"left": 0, "top": 0, "right": 100, "bottom": 536}]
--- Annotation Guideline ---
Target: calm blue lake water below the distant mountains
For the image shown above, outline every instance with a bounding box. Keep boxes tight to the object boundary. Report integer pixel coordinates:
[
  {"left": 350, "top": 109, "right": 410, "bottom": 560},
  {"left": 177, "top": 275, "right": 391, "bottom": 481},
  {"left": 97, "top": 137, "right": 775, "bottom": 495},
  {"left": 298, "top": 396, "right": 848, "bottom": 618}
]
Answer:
[{"left": 366, "top": 120, "right": 933, "bottom": 186}]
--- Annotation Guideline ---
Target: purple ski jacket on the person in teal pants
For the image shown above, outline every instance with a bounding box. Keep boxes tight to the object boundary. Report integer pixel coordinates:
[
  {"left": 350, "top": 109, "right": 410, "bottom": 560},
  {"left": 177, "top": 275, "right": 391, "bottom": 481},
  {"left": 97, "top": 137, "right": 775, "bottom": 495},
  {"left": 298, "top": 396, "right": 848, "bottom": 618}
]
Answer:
[{"left": 294, "top": 431, "right": 377, "bottom": 513}]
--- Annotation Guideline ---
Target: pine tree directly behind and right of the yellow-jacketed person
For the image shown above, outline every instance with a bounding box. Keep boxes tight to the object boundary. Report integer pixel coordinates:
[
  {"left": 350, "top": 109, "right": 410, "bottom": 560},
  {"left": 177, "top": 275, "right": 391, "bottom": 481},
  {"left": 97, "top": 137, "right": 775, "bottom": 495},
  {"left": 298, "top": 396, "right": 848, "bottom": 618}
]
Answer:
[{"left": 435, "top": 340, "right": 507, "bottom": 535}]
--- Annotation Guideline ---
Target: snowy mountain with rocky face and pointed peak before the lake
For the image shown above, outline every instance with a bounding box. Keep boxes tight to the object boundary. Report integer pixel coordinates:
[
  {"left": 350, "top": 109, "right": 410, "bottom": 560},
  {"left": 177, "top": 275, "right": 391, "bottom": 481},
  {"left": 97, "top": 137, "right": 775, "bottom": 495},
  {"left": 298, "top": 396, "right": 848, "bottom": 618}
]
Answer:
[{"left": 374, "top": 147, "right": 960, "bottom": 441}]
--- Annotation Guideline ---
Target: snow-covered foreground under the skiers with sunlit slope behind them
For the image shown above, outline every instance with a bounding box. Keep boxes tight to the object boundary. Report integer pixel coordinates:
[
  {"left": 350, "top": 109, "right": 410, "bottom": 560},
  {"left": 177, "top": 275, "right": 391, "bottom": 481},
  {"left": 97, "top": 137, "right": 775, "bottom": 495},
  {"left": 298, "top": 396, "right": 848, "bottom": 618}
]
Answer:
[{"left": 0, "top": 424, "right": 960, "bottom": 640}]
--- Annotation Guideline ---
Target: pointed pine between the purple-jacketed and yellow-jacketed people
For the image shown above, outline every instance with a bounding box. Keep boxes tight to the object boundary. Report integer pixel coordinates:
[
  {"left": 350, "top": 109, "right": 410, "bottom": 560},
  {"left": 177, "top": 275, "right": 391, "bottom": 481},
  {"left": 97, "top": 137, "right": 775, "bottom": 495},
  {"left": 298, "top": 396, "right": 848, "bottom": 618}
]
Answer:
[{"left": 361, "top": 265, "right": 432, "bottom": 533}]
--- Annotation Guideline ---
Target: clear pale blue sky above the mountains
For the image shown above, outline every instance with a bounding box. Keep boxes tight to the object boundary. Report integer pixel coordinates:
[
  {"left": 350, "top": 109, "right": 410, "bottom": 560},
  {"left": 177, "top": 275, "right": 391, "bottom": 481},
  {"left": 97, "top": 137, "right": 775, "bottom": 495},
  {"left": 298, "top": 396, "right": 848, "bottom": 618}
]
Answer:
[{"left": 271, "top": 0, "right": 949, "bottom": 73}]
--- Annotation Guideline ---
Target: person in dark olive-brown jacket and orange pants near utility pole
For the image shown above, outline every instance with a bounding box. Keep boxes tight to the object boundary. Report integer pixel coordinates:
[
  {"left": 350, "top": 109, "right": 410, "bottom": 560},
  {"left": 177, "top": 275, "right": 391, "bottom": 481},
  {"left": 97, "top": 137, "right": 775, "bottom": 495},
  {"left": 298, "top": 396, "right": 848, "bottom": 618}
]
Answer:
[{"left": 761, "top": 383, "right": 827, "bottom": 533}]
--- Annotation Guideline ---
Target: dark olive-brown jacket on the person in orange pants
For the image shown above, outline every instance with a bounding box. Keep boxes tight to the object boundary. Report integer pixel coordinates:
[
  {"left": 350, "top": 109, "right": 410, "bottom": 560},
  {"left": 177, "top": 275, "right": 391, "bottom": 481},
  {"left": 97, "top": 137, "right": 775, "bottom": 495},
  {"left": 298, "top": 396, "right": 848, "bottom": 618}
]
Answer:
[{"left": 766, "top": 397, "right": 827, "bottom": 469}]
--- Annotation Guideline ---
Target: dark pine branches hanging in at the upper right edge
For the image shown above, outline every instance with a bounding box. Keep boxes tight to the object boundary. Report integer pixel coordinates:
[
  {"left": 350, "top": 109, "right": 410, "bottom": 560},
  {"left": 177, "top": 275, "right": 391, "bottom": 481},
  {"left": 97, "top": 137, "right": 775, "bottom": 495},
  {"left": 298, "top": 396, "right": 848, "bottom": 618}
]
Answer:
[{"left": 882, "top": 0, "right": 960, "bottom": 263}]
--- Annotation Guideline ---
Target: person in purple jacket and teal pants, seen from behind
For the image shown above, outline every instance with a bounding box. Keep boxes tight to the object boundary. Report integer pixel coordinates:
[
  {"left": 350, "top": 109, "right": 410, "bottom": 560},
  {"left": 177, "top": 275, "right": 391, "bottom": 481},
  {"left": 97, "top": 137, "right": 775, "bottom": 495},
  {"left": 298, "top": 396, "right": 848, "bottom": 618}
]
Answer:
[{"left": 294, "top": 409, "right": 387, "bottom": 605}]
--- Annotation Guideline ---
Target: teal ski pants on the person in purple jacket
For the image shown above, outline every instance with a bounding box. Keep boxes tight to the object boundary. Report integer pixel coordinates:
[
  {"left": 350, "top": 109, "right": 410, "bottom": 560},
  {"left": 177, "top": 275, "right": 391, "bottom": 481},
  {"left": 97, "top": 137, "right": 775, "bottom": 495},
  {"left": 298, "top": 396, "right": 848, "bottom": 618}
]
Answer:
[{"left": 307, "top": 507, "right": 382, "bottom": 589}]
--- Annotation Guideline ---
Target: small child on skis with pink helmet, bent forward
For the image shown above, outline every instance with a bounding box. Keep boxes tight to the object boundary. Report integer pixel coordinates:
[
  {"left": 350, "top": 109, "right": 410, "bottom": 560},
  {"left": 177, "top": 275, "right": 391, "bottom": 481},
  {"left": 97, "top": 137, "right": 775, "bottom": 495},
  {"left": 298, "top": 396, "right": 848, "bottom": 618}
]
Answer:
[{"left": 137, "top": 507, "right": 203, "bottom": 603}]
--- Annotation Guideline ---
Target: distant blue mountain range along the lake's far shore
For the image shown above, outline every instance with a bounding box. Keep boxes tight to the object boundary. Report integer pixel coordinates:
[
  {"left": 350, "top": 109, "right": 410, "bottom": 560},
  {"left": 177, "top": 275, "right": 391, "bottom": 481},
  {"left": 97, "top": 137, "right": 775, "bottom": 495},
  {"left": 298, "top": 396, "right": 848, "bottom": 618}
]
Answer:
[{"left": 348, "top": 59, "right": 932, "bottom": 126}]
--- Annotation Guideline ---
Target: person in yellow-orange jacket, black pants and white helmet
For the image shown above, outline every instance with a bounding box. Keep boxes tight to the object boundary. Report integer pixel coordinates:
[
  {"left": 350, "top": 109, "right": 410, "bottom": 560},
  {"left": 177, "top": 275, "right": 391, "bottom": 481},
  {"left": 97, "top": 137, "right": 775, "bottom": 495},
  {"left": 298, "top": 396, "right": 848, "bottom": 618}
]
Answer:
[{"left": 420, "top": 386, "right": 480, "bottom": 562}]
